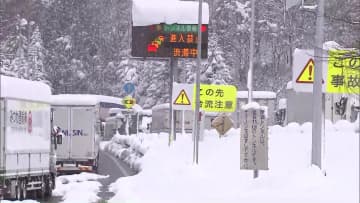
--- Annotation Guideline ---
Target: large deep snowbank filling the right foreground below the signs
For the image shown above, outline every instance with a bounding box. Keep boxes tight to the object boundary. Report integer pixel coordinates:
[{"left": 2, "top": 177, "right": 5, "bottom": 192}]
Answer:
[{"left": 109, "top": 121, "right": 359, "bottom": 203}]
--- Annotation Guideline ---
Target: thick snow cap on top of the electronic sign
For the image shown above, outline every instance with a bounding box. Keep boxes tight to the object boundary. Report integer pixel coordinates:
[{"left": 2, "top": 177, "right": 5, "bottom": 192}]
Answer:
[{"left": 132, "top": 0, "right": 209, "bottom": 26}]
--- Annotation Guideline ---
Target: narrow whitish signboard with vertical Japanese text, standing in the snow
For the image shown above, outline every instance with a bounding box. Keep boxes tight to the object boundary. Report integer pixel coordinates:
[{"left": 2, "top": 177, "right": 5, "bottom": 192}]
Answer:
[{"left": 240, "top": 108, "right": 268, "bottom": 170}]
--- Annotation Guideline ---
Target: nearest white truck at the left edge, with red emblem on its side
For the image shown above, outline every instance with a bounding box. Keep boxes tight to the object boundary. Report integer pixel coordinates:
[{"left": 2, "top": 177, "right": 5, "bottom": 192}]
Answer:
[{"left": 0, "top": 75, "right": 56, "bottom": 199}]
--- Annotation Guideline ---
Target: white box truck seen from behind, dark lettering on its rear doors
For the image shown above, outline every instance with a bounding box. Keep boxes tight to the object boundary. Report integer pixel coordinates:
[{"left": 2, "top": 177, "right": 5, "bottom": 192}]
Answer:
[{"left": 51, "top": 94, "right": 125, "bottom": 174}]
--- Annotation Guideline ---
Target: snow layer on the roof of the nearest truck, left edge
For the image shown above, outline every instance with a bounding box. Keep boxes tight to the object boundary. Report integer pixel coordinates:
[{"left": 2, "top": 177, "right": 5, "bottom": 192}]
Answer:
[{"left": 0, "top": 75, "right": 51, "bottom": 103}]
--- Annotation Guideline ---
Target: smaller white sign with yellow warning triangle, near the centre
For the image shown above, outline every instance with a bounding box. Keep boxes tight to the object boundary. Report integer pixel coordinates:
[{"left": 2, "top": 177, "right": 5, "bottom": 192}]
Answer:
[{"left": 172, "top": 83, "right": 194, "bottom": 110}]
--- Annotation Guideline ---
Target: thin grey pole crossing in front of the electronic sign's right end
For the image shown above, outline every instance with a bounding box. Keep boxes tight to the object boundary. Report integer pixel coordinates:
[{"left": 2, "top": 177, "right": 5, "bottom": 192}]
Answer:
[{"left": 193, "top": 0, "right": 202, "bottom": 164}]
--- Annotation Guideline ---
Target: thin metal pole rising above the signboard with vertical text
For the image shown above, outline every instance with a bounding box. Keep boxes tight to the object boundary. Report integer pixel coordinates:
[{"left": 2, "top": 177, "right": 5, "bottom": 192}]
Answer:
[{"left": 247, "top": 0, "right": 259, "bottom": 178}]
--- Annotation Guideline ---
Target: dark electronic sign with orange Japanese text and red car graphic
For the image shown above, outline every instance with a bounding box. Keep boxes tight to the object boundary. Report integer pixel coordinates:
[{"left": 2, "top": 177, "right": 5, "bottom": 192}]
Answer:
[{"left": 131, "top": 24, "right": 208, "bottom": 58}]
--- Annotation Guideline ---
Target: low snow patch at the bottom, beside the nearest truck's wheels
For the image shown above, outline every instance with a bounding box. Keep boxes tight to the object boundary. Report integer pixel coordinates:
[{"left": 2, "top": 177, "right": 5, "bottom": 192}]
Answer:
[{"left": 53, "top": 173, "right": 109, "bottom": 203}]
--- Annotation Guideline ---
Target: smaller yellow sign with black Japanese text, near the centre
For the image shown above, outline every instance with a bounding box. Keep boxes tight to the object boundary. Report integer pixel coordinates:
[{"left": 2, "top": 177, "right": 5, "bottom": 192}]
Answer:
[{"left": 193, "top": 84, "right": 237, "bottom": 112}]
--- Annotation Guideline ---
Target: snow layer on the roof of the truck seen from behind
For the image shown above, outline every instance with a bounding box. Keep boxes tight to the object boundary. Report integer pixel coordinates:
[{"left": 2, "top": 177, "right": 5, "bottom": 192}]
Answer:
[{"left": 51, "top": 94, "right": 122, "bottom": 105}]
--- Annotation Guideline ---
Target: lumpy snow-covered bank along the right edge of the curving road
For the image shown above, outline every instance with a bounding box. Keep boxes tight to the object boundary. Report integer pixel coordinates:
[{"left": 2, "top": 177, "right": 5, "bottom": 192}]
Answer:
[{"left": 104, "top": 133, "right": 162, "bottom": 171}]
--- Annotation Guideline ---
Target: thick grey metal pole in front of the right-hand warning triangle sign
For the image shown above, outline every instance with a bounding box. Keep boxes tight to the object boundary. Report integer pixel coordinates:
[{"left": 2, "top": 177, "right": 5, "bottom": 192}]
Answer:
[{"left": 311, "top": 0, "right": 324, "bottom": 173}]
